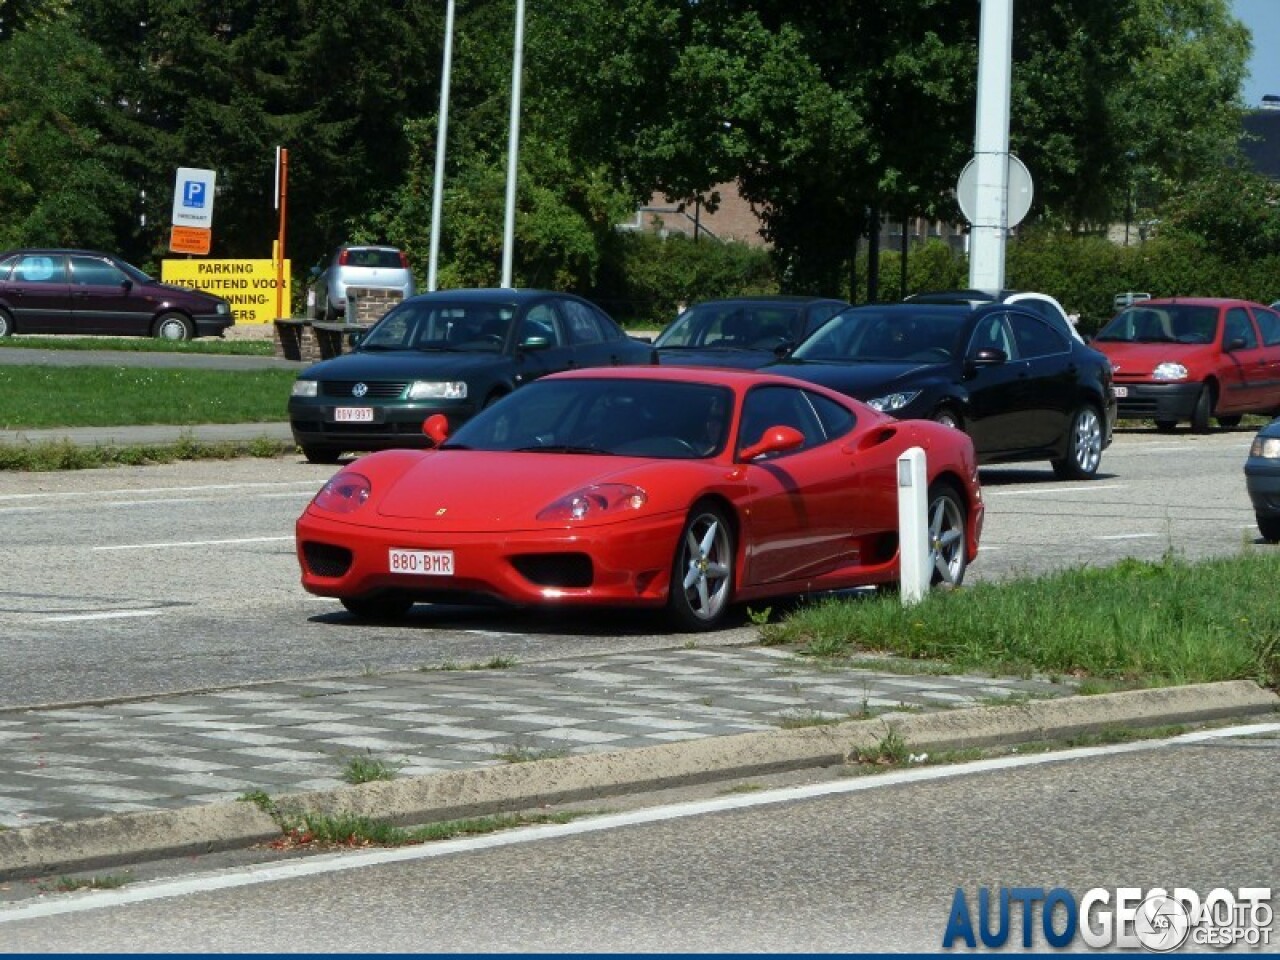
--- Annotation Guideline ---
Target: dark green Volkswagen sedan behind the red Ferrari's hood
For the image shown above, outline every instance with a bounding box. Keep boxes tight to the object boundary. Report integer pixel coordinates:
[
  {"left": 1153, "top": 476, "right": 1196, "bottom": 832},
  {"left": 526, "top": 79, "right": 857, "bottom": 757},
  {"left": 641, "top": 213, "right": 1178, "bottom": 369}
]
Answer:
[{"left": 289, "top": 289, "right": 654, "bottom": 463}]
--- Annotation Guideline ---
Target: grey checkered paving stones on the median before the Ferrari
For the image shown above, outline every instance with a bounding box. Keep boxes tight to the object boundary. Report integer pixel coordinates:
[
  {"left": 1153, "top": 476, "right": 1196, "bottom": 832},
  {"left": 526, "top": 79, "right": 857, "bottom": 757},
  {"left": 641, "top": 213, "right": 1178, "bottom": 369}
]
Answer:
[{"left": 0, "top": 646, "right": 1074, "bottom": 827}]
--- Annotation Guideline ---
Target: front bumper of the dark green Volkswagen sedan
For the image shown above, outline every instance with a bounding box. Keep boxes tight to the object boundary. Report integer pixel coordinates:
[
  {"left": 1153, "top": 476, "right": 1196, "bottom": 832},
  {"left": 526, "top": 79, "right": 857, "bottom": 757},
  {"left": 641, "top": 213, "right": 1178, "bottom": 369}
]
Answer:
[{"left": 289, "top": 397, "right": 476, "bottom": 451}]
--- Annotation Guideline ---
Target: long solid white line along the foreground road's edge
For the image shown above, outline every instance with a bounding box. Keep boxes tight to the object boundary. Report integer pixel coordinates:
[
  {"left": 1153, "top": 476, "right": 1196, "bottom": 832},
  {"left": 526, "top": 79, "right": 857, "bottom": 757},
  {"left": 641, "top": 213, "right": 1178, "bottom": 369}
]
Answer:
[{"left": 0, "top": 723, "right": 1280, "bottom": 923}]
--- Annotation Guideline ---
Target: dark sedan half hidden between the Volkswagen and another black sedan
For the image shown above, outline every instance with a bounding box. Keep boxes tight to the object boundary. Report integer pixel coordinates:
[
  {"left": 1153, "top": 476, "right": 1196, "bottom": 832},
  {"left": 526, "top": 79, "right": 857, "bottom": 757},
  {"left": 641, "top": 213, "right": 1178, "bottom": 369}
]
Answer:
[{"left": 653, "top": 296, "right": 849, "bottom": 370}]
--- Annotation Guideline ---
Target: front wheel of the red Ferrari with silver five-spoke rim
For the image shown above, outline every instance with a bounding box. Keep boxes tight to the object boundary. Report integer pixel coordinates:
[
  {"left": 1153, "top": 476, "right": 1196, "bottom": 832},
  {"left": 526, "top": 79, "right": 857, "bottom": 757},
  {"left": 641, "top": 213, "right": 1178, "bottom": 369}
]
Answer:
[{"left": 667, "top": 503, "right": 736, "bottom": 631}]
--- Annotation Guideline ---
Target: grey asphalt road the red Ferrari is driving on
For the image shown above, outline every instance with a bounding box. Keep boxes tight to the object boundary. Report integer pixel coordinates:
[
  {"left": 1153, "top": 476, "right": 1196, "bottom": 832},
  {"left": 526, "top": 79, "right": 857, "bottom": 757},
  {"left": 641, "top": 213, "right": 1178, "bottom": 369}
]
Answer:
[{"left": 0, "top": 430, "right": 1275, "bottom": 708}]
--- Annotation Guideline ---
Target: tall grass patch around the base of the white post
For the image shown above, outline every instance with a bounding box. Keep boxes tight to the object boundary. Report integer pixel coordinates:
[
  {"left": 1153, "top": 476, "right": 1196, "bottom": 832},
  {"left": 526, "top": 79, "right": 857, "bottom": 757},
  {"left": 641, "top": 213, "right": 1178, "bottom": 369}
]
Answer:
[{"left": 763, "top": 550, "right": 1280, "bottom": 690}]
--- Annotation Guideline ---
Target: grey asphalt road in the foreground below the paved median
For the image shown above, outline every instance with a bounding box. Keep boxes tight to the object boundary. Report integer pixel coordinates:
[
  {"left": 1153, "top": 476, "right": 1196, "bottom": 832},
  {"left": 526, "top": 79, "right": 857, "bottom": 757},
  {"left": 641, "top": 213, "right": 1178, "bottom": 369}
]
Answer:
[{"left": 0, "top": 724, "right": 1280, "bottom": 954}]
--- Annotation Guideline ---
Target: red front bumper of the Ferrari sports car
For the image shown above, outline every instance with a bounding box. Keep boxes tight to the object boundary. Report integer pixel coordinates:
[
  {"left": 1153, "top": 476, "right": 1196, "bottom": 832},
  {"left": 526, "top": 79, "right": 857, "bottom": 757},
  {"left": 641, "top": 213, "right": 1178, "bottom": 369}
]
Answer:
[{"left": 296, "top": 508, "right": 684, "bottom": 607}]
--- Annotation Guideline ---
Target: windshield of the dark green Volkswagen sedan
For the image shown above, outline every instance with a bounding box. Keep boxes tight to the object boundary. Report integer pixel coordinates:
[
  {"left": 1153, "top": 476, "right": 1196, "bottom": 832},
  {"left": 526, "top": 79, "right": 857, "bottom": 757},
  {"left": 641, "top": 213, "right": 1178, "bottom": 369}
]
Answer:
[{"left": 360, "top": 302, "right": 516, "bottom": 353}]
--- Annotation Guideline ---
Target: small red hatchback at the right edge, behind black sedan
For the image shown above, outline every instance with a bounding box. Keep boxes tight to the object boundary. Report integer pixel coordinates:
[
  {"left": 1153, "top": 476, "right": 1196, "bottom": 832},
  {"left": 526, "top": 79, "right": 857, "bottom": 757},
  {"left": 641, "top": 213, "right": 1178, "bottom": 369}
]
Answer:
[{"left": 1092, "top": 297, "right": 1280, "bottom": 433}]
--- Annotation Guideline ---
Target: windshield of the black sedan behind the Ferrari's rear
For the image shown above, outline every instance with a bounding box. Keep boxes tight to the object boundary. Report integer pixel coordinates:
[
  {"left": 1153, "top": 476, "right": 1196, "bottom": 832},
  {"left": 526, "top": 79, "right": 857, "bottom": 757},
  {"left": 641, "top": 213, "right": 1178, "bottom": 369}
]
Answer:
[{"left": 791, "top": 305, "right": 969, "bottom": 364}]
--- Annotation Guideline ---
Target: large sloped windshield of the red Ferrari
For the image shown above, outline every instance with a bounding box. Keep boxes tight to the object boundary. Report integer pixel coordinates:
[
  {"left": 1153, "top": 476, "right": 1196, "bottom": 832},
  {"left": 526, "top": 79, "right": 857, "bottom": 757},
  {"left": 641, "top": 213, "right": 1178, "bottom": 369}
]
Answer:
[{"left": 444, "top": 379, "right": 733, "bottom": 460}]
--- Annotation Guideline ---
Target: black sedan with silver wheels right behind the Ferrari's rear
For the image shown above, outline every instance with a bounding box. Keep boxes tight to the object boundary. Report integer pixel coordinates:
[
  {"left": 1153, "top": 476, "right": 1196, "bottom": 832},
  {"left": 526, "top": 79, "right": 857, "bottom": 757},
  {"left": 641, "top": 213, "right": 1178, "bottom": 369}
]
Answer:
[{"left": 767, "top": 302, "right": 1116, "bottom": 480}]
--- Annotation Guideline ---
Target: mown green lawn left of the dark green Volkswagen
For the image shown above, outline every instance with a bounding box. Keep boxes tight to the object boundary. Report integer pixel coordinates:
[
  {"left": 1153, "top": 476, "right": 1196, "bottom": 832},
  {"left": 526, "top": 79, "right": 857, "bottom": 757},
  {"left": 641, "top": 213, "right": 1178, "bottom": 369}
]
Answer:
[{"left": 0, "top": 365, "right": 297, "bottom": 430}]
